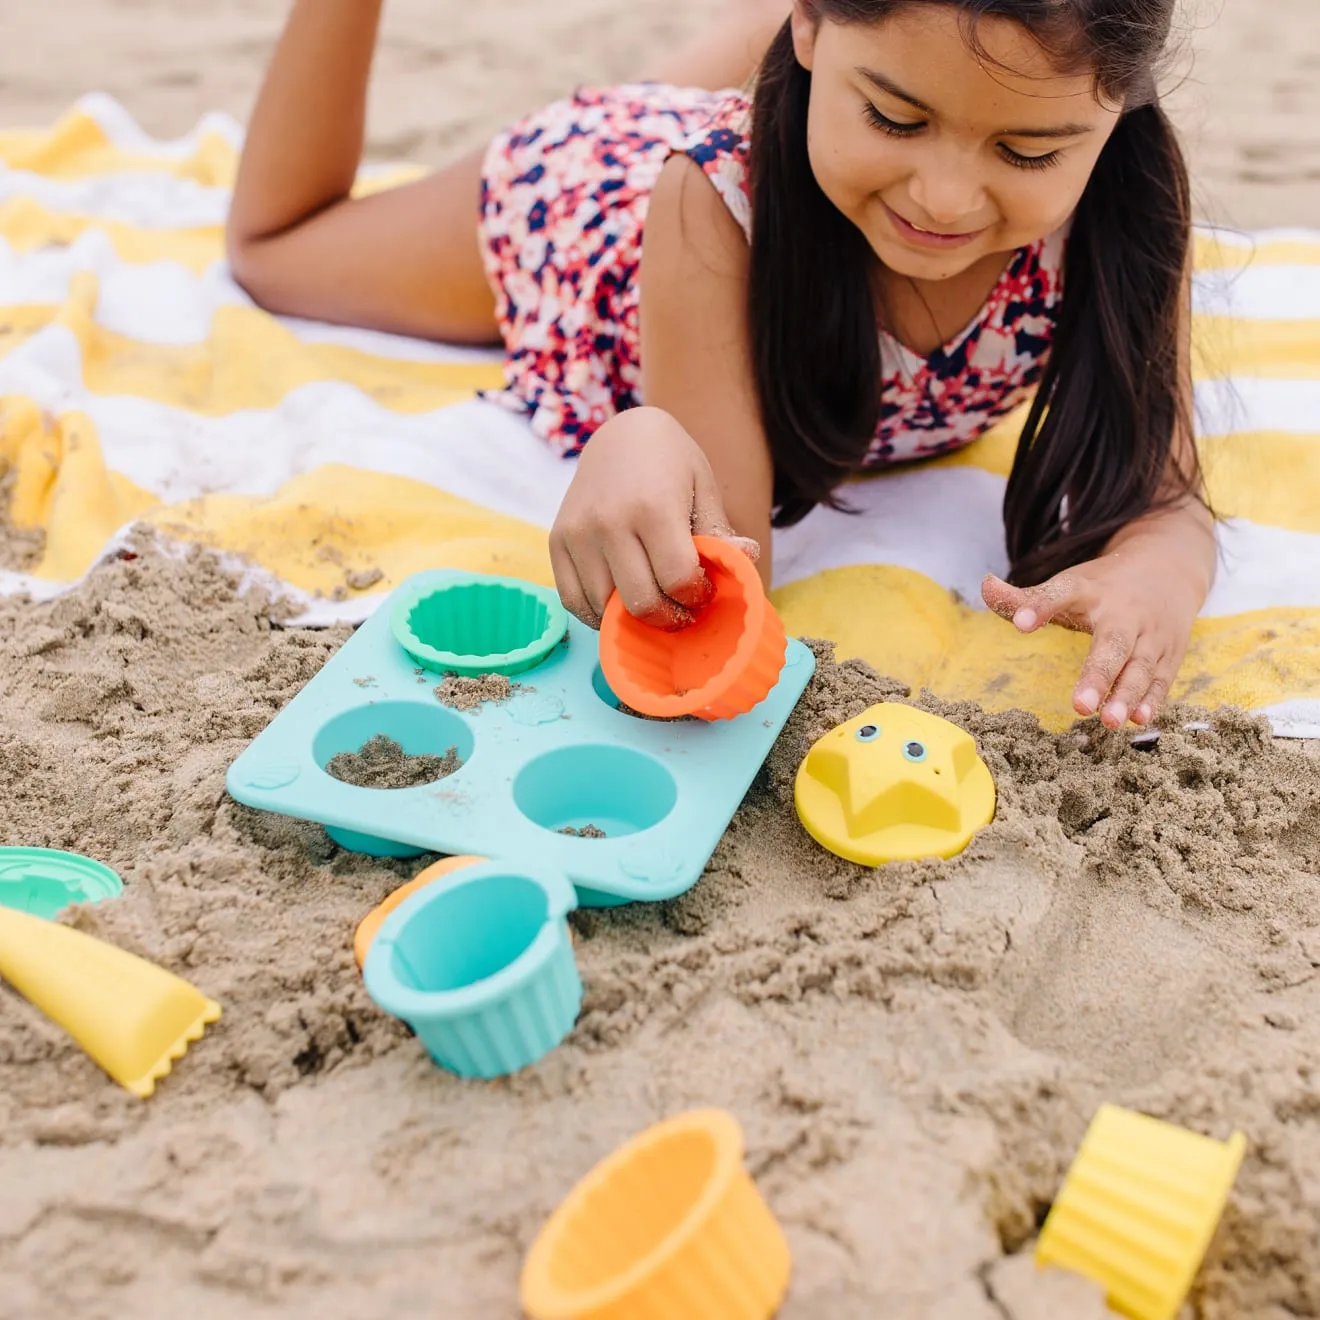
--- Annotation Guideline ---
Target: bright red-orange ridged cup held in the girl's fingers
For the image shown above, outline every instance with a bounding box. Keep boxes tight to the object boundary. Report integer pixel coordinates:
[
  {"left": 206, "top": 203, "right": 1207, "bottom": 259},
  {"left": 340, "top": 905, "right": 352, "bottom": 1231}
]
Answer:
[{"left": 601, "top": 536, "right": 788, "bottom": 719}]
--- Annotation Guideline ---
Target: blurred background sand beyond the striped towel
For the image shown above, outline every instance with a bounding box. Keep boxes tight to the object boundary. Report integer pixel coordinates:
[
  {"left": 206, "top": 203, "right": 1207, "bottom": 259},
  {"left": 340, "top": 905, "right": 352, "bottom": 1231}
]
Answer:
[{"left": 0, "top": 0, "right": 1320, "bottom": 227}]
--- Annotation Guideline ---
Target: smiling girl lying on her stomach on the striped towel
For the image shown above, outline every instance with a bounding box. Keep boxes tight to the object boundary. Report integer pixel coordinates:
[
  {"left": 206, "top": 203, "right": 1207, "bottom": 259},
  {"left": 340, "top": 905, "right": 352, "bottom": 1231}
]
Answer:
[{"left": 230, "top": 0, "right": 1214, "bottom": 729}]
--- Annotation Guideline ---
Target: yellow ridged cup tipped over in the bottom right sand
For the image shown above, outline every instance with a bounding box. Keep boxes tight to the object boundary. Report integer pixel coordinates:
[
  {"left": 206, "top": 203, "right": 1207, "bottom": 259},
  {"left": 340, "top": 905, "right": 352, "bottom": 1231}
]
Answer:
[{"left": 1036, "top": 1105, "right": 1246, "bottom": 1320}]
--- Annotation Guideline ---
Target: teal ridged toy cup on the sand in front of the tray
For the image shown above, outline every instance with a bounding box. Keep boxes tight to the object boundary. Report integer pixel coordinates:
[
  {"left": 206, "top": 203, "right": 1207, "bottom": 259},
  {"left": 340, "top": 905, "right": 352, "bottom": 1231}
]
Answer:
[{"left": 363, "top": 862, "right": 582, "bottom": 1077}]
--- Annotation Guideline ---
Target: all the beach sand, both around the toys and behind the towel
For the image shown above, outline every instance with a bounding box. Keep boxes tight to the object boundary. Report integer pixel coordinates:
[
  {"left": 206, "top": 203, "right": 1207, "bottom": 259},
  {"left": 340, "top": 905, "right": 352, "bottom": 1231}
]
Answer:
[{"left": 0, "top": 0, "right": 1320, "bottom": 1320}]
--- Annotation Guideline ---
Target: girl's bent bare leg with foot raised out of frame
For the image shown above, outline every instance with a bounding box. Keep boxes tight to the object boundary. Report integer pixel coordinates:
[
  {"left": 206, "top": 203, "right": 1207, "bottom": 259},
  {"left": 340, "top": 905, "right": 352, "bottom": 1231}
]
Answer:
[{"left": 227, "top": 0, "right": 496, "bottom": 341}]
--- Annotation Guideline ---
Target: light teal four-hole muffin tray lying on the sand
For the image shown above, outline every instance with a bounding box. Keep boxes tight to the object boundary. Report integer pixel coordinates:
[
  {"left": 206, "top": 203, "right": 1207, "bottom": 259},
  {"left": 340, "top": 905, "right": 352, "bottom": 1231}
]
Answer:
[{"left": 226, "top": 570, "right": 816, "bottom": 907}]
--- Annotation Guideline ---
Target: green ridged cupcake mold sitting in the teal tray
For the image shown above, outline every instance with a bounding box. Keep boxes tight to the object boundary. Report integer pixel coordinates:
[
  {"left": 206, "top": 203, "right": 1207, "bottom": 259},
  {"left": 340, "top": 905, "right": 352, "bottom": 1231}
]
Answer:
[{"left": 391, "top": 573, "right": 569, "bottom": 676}]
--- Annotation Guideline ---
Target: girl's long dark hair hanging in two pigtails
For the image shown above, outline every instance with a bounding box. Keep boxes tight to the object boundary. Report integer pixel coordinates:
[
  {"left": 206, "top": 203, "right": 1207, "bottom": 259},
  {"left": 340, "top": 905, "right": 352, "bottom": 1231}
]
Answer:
[{"left": 748, "top": 0, "right": 1201, "bottom": 585}]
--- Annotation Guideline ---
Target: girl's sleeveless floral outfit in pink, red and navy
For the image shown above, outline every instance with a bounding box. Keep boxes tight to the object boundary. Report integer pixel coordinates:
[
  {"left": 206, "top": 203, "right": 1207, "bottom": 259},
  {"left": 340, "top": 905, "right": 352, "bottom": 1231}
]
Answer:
[{"left": 479, "top": 83, "right": 1064, "bottom": 467}]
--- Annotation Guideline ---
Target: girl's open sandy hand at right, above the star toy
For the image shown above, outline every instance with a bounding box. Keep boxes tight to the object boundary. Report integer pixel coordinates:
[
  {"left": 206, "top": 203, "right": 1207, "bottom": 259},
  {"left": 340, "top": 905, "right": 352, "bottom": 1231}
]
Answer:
[{"left": 981, "top": 549, "right": 1205, "bottom": 729}]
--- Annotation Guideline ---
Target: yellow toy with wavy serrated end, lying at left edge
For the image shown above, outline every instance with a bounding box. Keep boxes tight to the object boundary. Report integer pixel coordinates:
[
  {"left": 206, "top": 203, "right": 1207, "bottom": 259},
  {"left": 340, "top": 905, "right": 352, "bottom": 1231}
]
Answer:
[{"left": 0, "top": 908, "right": 220, "bottom": 1100}]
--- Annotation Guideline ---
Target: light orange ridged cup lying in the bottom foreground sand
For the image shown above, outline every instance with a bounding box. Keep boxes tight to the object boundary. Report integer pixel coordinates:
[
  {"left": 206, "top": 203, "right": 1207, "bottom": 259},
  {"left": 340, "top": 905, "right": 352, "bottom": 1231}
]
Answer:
[{"left": 521, "top": 1109, "right": 792, "bottom": 1320}]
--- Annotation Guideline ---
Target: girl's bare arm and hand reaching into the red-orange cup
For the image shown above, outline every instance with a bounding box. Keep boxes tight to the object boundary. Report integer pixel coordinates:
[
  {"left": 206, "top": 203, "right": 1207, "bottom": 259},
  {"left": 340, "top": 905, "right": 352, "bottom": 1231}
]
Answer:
[{"left": 550, "top": 156, "right": 774, "bottom": 624}]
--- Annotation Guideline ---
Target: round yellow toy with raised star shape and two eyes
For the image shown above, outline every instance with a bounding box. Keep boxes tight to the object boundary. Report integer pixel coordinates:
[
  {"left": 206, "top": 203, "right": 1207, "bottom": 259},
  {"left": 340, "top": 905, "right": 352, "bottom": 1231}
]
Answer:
[{"left": 793, "top": 701, "right": 995, "bottom": 866}]
